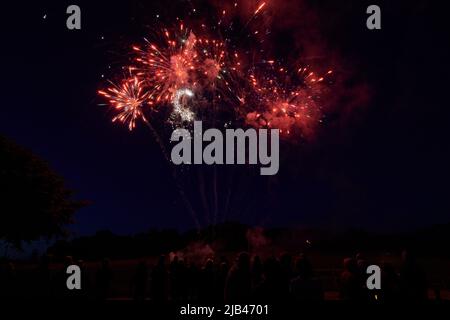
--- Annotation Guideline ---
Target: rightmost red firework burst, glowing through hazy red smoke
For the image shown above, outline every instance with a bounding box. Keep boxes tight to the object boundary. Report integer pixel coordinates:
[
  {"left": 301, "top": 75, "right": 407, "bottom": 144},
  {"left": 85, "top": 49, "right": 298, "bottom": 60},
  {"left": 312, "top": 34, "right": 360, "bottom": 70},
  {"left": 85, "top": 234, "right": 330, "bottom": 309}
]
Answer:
[{"left": 245, "top": 64, "right": 332, "bottom": 137}]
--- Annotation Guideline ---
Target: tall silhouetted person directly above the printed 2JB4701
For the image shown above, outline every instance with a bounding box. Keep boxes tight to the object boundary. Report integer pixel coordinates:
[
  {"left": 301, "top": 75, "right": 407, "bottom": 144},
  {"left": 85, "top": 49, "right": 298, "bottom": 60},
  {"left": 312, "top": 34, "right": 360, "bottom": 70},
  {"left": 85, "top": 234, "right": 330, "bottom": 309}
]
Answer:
[{"left": 225, "top": 252, "right": 251, "bottom": 303}]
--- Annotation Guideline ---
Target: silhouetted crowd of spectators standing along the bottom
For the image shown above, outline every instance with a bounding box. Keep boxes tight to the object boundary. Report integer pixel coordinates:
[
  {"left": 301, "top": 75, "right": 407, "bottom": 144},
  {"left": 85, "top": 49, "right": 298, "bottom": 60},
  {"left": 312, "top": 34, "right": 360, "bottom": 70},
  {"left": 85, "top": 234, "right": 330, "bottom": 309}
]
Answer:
[{"left": 0, "top": 251, "right": 427, "bottom": 303}]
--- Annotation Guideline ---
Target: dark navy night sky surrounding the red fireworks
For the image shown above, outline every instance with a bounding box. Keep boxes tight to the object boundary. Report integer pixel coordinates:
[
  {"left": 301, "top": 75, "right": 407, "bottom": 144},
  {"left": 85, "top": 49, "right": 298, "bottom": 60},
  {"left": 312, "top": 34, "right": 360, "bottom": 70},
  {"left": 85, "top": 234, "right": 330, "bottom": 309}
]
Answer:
[{"left": 0, "top": 1, "right": 450, "bottom": 234}]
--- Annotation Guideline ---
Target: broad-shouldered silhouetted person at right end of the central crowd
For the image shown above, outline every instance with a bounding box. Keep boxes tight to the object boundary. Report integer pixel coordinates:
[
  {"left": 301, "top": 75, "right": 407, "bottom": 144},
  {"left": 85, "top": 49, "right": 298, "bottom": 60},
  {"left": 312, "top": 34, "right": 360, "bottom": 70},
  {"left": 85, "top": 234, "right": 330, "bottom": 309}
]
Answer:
[{"left": 290, "top": 256, "right": 324, "bottom": 301}]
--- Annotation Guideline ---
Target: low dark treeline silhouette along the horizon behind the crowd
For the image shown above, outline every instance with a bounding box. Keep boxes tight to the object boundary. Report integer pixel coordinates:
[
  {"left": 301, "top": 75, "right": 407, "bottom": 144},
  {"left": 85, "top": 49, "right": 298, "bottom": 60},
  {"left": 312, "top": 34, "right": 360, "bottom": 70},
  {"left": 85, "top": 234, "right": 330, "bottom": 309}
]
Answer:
[{"left": 47, "top": 222, "right": 450, "bottom": 260}]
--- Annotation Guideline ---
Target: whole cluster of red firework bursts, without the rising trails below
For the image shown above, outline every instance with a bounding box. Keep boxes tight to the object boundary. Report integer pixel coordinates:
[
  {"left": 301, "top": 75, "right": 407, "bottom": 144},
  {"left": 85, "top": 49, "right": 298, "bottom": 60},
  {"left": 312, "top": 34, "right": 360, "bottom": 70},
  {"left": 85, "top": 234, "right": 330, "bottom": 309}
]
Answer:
[{"left": 99, "top": 2, "right": 331, "bottom": 136}]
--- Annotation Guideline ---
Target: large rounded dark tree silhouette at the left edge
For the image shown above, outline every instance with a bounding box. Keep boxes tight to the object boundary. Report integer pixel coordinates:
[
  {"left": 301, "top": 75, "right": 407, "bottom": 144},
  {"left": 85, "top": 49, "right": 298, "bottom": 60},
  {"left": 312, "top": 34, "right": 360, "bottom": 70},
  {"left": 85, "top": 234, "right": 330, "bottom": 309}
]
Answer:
[{"left": 0, "top": 136, "right": 84, "bottom": 248}]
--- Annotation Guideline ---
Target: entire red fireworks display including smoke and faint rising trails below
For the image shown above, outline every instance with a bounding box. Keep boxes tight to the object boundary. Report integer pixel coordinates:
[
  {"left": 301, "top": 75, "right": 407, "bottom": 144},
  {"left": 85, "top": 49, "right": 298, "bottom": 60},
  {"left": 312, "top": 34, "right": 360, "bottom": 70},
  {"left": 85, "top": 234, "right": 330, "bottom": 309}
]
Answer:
[{"left": 95, "top": 1, "right": 342, "bottom": 226}]
